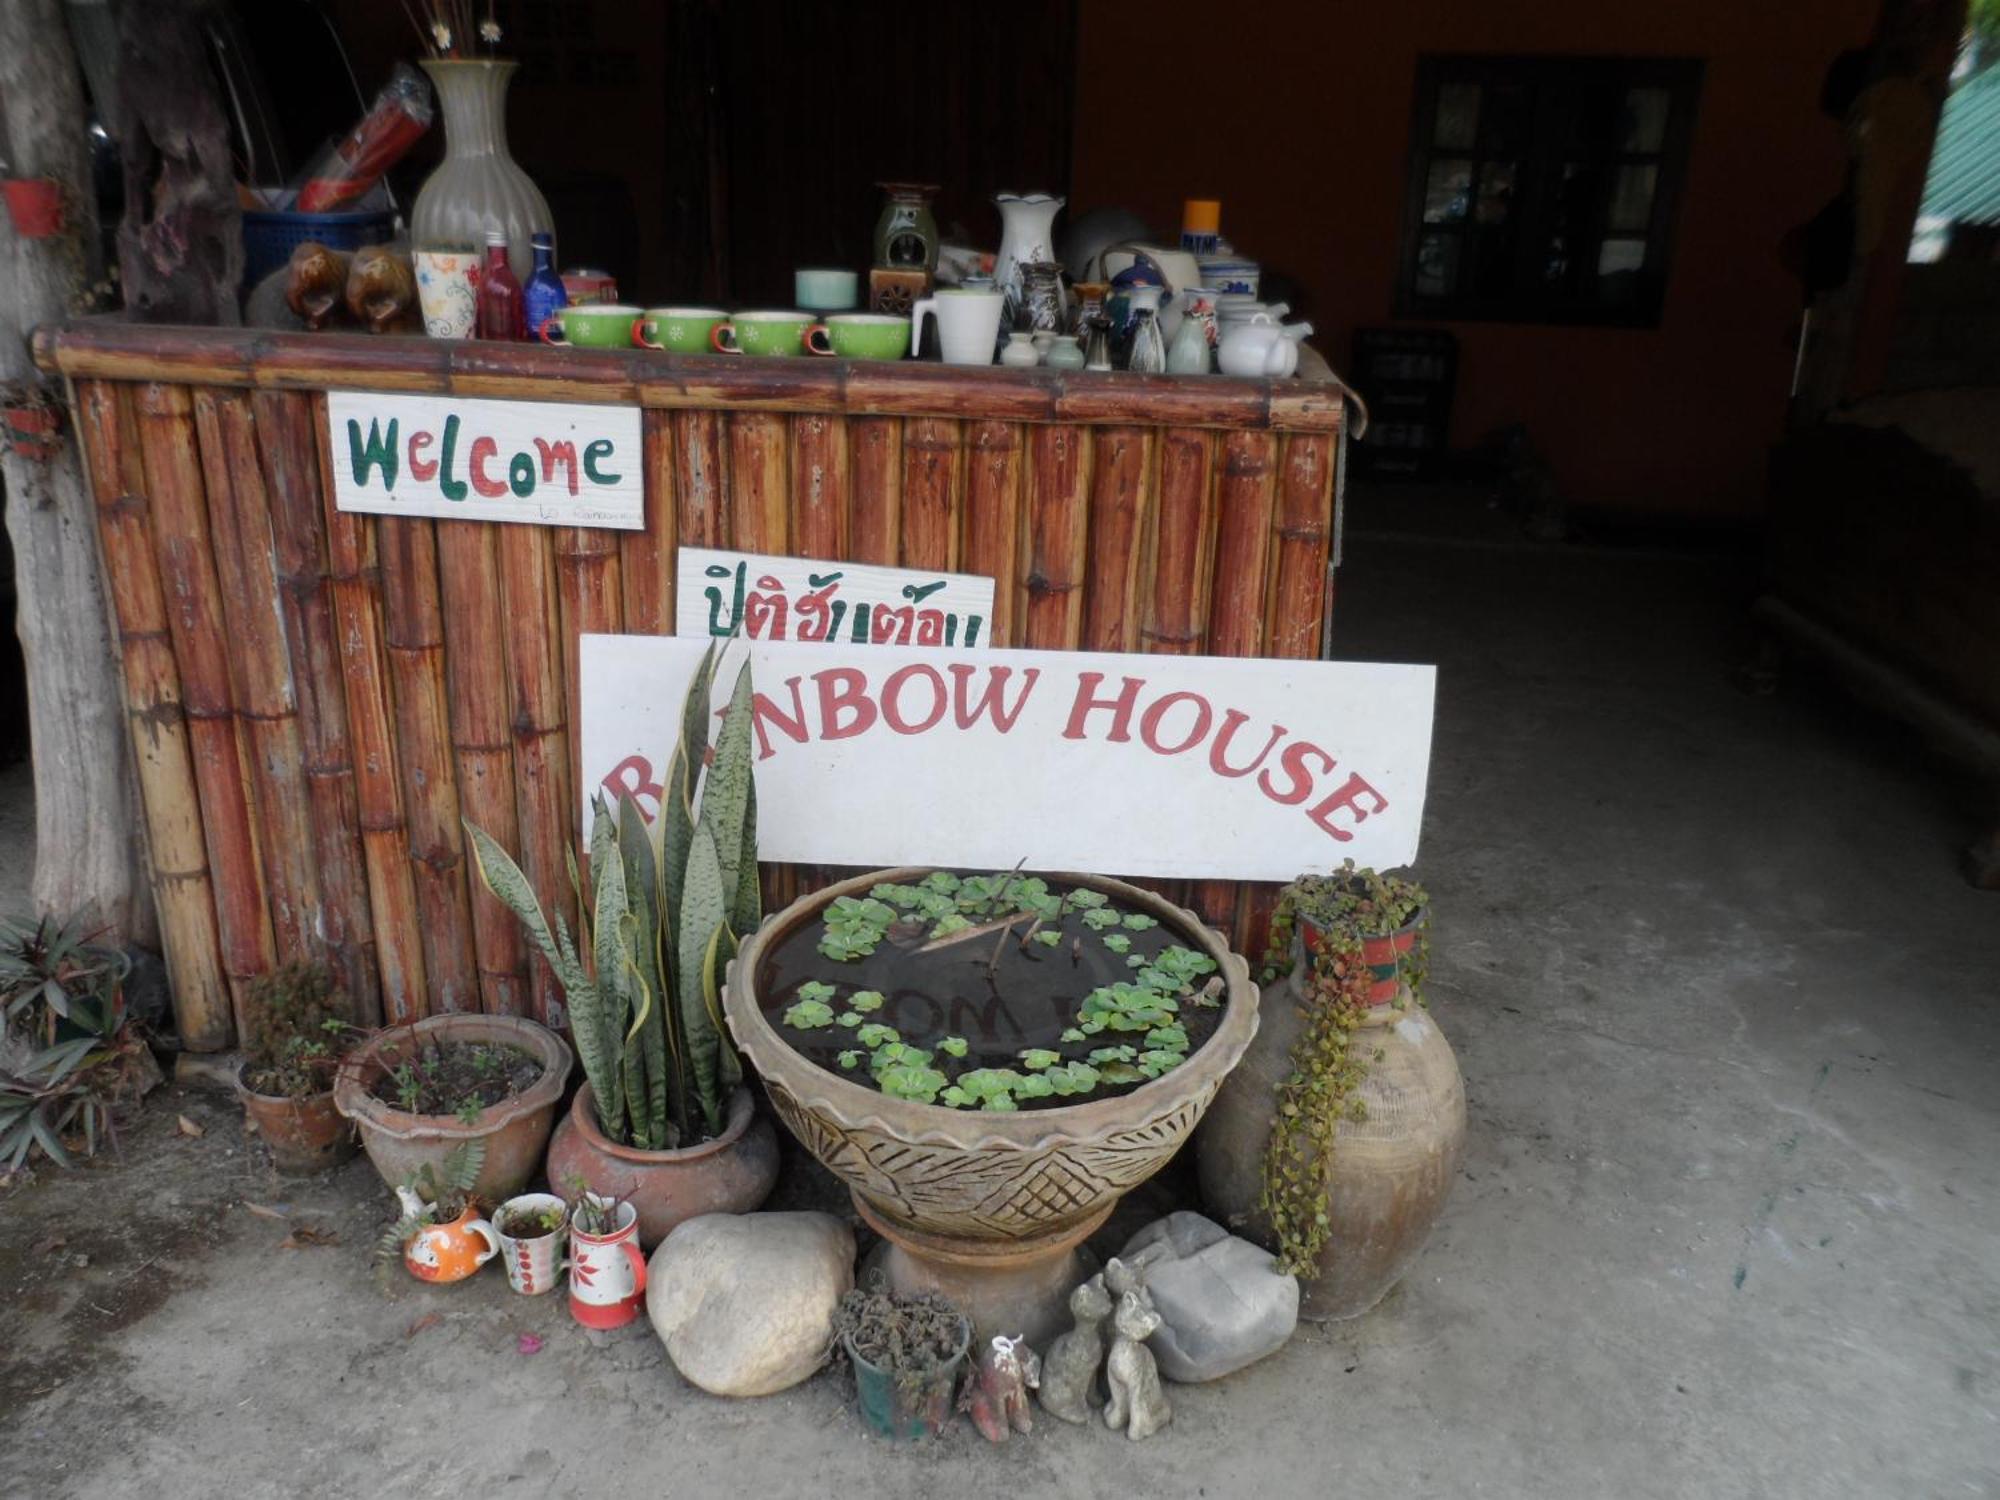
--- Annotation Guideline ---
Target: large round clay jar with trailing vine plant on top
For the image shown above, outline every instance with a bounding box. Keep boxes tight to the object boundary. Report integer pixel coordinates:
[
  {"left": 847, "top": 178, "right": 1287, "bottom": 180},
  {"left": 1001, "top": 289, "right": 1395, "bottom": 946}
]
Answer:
[{"left": 1198, "top": 862, "right": 1466, "bottom": 1320}]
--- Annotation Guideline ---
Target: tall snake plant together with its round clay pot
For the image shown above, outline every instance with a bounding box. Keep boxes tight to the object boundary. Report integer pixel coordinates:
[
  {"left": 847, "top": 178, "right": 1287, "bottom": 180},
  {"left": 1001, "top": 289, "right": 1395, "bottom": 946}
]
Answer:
[{"left": 466, "top": 648, "right": 778, "bottom": 1248}]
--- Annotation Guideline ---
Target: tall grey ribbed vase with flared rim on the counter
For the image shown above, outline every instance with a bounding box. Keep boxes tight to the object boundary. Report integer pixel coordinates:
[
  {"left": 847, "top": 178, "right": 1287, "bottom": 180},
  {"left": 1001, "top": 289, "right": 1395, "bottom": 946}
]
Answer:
[{"left": 410, "top": 58, "right": 556, "bottom": 284}]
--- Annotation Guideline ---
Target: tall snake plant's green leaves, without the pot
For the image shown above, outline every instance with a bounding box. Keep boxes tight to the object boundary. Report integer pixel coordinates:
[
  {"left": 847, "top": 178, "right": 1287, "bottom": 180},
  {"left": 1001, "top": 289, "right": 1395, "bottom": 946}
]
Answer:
[{"left": 466, "top": 646, "right": 762, "bottom": 1150}]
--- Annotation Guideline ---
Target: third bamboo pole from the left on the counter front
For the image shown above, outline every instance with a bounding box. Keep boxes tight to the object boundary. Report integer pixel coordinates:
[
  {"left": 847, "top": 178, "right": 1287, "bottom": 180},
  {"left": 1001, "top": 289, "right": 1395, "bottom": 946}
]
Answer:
[{"left": 194, "top": 388, "right": 326, "bottom": 976}]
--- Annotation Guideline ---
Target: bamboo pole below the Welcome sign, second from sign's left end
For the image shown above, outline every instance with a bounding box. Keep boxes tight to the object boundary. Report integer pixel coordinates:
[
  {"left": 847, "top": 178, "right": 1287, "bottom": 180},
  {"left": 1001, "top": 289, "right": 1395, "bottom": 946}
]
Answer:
[{"left": 376, "top": 516, "right": 480, "bottom": 1014}]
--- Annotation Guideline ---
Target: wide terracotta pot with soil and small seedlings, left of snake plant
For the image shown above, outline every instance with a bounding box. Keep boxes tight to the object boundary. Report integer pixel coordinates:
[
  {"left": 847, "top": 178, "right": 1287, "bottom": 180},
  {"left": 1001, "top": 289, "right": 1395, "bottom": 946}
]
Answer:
[{"left": 334, "top": 1014, "right": 570, "bottom": 1202}]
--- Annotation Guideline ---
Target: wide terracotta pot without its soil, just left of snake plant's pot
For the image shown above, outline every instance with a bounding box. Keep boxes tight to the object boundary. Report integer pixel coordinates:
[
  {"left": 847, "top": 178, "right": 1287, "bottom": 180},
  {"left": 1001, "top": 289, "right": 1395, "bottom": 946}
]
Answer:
[{"left": 334, "top": 1016, "right": 570, "bottom": 1204}]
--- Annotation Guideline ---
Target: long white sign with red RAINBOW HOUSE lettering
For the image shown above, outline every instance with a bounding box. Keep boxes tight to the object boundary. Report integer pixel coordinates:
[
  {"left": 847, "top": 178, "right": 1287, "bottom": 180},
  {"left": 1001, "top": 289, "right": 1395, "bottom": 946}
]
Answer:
[{"left": 580, "top": 636, "right": 1436, "bottom": 880}]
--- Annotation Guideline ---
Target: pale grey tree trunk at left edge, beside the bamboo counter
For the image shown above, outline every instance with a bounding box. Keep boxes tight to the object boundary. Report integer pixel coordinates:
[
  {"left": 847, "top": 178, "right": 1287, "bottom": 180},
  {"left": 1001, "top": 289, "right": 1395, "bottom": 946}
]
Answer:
[{"left": 0, "top": 0, "right": 156, "bottom": 942}]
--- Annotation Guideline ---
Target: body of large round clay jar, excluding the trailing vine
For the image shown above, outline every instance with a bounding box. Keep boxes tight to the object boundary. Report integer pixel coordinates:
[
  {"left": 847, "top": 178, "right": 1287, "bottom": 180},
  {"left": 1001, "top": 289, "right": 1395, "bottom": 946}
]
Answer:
[{"left": 1196, "top": 970, "right": 1466, "bottom": 1322}]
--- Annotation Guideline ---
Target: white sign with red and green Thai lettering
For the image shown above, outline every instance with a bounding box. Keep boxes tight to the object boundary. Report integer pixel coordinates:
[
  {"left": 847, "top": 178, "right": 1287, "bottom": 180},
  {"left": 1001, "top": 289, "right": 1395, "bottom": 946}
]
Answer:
[{"left": 674, "top": 546, "right": 994, "bottom": 650}]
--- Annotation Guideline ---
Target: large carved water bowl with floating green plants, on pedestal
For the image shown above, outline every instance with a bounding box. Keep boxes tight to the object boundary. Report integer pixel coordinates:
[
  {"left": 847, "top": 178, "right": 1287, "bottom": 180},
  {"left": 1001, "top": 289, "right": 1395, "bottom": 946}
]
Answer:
[{"left": 726, "top": 868, "right": 1256, "bottom": 1342}]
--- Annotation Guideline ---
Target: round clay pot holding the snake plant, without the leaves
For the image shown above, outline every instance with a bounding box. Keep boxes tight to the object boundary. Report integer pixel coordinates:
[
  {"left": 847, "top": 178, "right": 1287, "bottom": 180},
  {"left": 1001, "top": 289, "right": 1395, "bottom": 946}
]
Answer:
[{"left": 548, "top": 1082, "right": 778, "bottom": 1250}]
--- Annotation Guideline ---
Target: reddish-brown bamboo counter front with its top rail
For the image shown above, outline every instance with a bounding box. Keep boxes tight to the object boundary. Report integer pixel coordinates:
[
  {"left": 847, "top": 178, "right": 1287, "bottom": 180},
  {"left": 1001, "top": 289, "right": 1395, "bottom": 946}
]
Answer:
[{"left": 36, "top": 320, "right": 1342, "bottom": 1050}]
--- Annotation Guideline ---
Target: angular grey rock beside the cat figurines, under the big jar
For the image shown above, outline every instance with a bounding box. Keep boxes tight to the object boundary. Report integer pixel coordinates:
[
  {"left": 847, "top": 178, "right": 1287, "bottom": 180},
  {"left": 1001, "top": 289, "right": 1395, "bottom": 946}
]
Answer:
[{"left": 1118, "top": 1210, "right": 1298, "bottom": 1384}]
